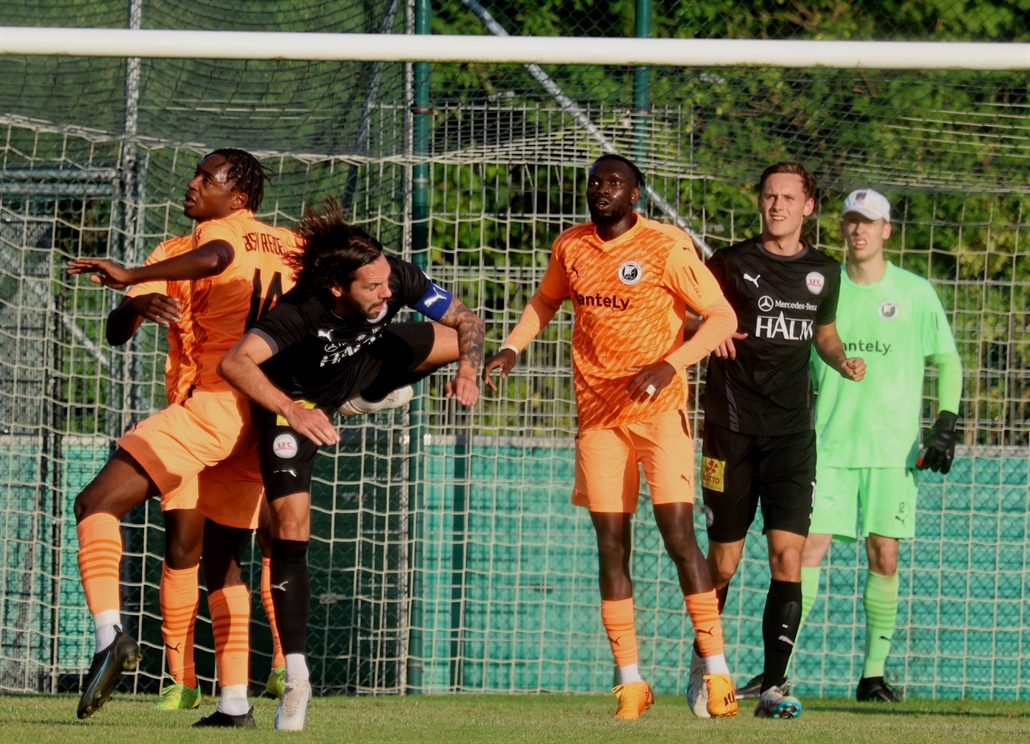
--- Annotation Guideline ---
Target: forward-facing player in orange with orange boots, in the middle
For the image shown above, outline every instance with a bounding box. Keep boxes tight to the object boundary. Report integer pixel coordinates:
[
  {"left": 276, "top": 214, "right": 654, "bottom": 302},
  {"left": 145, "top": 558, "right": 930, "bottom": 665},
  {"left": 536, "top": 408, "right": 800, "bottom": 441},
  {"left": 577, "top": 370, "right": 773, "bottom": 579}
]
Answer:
[{"left": 483, "top": 155, "right": 736, "bottom": 718}]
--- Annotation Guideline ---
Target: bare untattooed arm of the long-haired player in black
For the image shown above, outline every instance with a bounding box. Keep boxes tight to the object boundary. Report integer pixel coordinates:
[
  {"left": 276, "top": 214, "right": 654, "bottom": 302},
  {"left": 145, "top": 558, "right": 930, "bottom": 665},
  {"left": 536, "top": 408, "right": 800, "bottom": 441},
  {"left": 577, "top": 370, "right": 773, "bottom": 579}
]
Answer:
[{"left": 218, "top": 333, "right": 340, "bottom": 446}]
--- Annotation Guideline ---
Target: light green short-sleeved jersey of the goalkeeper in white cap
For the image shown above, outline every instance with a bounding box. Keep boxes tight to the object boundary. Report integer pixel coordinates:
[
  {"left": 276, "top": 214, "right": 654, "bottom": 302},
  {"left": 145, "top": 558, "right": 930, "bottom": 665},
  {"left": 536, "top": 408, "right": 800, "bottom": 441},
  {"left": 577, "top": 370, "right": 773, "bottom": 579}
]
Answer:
[{"left": 812, "top": 263, "right": 956, "bottom": 468}]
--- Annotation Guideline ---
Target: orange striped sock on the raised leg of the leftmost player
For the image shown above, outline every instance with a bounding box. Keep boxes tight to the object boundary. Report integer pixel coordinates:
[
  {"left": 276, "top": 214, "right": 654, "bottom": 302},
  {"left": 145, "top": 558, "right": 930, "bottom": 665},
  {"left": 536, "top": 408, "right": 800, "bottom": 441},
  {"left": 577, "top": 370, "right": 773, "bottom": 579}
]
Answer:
[{"left": 75, "top": 513, "right": 122, "bottom": 622}]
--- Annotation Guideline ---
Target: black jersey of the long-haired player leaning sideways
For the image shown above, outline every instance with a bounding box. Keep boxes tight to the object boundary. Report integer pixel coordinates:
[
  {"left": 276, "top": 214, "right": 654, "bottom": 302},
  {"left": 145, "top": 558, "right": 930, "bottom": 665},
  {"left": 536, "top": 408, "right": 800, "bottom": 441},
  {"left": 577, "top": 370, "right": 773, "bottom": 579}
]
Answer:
[{"left": 250, "top": 257, "right": 435, "bottom": 411}]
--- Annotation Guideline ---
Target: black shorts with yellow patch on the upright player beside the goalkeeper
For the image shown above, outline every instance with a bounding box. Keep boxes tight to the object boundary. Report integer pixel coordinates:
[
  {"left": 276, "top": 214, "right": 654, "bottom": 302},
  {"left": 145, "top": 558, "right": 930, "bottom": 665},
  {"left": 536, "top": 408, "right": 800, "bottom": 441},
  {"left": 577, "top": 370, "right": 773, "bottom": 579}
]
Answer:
[{"left": 701, "top": 422, "right": 816, "bottom": 542}]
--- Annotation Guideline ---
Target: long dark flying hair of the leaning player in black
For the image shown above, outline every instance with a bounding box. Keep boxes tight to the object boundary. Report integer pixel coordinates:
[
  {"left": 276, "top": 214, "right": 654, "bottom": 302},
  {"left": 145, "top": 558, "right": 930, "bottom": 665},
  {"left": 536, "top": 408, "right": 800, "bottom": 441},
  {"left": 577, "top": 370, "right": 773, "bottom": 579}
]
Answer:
[{"left": 286, "top": 197, "right": 383, "bottom": 290}]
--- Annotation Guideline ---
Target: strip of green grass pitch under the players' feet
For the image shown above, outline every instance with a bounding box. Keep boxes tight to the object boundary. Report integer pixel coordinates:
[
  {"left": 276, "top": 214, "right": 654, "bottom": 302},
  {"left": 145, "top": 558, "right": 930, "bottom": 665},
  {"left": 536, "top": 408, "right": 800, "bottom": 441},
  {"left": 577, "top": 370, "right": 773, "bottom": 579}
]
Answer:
[{"left": 0, "top": 695, "right": 1030, "bottom": 744}]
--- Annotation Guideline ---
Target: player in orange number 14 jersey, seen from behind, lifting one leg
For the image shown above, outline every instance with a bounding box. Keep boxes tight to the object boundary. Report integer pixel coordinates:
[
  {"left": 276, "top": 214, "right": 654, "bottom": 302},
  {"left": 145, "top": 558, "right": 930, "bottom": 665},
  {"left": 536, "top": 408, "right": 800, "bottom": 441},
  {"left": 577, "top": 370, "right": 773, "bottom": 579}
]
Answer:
[{"left": 69, "top": 149, "right": 297, "bottom": 728}]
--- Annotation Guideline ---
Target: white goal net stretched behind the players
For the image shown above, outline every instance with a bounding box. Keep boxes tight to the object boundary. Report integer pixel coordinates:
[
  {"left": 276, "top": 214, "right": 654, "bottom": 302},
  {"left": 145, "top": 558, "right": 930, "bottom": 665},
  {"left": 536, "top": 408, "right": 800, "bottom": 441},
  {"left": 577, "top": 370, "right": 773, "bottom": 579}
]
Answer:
[{"left": 0, "top": 0, "right": 1030, "bottom": 699}]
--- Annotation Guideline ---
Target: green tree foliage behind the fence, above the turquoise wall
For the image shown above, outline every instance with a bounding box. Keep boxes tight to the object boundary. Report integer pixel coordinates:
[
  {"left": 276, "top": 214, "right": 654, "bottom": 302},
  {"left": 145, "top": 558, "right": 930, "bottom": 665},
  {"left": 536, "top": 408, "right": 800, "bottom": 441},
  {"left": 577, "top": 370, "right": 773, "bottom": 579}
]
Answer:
[{"left": 422, "top": 0, "right": 1030, "bottom": 443}]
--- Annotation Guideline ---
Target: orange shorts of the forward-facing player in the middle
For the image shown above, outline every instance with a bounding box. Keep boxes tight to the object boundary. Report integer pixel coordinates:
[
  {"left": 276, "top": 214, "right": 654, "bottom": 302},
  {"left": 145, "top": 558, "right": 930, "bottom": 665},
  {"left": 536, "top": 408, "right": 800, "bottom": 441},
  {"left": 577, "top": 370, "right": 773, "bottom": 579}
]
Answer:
[{"left": 573, "top": 410, "right": 694, "bottom": 514}]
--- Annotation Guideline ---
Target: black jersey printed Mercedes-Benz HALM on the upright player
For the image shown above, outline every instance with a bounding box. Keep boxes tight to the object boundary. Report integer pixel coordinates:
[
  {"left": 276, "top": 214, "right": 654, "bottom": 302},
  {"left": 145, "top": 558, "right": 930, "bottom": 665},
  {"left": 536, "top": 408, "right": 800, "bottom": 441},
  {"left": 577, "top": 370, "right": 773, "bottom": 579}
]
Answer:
[{"left": 705, "top": 239, "right": 840, "bottom": 436}]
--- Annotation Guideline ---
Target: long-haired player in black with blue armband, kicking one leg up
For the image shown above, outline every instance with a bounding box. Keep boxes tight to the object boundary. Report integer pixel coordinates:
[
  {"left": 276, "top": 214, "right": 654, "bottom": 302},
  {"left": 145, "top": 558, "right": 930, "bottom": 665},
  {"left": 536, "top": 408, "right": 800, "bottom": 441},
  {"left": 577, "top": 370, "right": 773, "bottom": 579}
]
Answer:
[{"left": 218, "top": 199, "right": 484, "bottom": 731}]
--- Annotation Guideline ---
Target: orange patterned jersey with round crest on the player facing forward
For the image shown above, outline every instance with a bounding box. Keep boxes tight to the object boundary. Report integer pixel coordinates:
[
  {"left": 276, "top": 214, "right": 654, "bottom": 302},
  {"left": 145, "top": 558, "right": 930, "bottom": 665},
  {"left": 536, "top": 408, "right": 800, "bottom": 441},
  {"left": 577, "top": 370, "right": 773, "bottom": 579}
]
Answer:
[{"left": 505, "top": 217, "right": 733, "bottom": 429}]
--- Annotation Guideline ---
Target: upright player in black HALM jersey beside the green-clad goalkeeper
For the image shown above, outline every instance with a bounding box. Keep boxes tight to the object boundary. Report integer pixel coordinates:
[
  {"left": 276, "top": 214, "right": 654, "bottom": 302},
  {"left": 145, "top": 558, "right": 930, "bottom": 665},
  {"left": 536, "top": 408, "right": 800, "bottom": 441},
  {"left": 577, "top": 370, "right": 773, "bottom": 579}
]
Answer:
[{"left": 688, "top": 163, "right": 865, "bottom": 718}]
